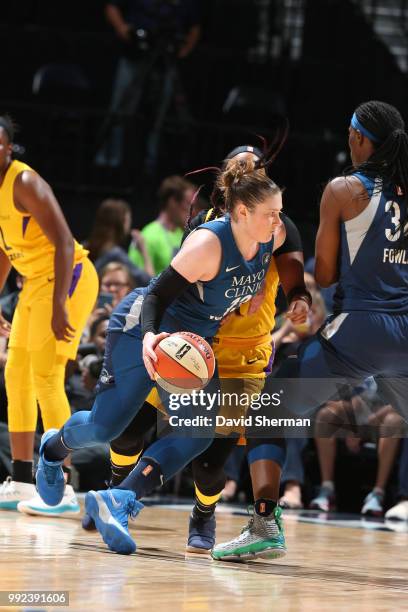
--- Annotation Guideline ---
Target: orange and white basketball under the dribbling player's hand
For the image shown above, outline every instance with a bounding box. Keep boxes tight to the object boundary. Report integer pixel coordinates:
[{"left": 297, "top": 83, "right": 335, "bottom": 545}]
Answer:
[{"left": 155, "top": 332, "right": 215, "bottom": 393}]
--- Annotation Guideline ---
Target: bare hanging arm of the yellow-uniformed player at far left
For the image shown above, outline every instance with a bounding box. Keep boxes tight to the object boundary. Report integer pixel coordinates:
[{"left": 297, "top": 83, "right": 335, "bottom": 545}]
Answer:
[{"left": 14, "top": 171, "right": 75, "bottom": 342}]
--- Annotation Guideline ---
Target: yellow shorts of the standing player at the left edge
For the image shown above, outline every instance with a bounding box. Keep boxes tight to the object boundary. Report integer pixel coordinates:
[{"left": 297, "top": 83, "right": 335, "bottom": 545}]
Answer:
[{"left": 9, "top": 257, "right": 99, "bottom": 359}]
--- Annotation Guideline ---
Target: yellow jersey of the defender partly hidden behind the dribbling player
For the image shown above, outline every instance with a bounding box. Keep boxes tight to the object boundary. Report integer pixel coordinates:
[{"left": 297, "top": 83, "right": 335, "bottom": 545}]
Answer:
[{"left": 216, "top": 258, "right": 279, "bottom": 341}]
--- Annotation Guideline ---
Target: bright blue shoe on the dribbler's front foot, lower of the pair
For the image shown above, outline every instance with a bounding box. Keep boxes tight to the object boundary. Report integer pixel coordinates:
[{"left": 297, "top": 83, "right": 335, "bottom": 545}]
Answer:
[{"left": 85, "top": 489, "right": 144, "bottom": 555}]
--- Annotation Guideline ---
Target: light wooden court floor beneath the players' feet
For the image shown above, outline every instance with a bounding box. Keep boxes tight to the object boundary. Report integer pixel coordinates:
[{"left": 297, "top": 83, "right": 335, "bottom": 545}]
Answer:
[{"left": 0, "top": 507, "right": 408, "bottom": 612}]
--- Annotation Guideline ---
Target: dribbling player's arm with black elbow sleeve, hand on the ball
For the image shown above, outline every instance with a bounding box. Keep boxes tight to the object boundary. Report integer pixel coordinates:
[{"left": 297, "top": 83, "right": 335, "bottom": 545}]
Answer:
[{"left": 141, "top": 229, "right": 222, "bottom": 380}]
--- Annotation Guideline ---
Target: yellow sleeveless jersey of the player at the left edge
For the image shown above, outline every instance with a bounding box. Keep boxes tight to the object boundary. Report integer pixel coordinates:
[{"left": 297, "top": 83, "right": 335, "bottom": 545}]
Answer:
[{"left": 0, "top": 160, "right": 88, "bottom": 279}]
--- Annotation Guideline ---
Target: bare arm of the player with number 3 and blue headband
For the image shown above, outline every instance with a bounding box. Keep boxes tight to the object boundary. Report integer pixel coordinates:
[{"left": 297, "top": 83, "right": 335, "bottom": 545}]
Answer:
[{"left": 315, "top": 177, "right": 344, "bottom": 287}]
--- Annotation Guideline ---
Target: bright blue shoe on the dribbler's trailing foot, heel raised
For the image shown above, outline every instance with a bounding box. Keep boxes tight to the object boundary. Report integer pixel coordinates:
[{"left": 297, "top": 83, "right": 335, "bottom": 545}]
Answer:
[{"left": 35, "top": 429, "right": 65, "bottom": 506}]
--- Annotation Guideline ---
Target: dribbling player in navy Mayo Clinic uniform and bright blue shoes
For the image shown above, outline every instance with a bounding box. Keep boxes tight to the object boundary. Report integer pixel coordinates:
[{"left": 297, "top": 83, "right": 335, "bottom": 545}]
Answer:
[{"left": 37, "top": 149, "right": 285, "bottom": 554}]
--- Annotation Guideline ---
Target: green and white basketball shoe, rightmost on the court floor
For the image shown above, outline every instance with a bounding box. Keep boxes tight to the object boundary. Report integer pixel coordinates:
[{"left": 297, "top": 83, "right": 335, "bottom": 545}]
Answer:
[{"left": 211, "top": 506, "right": 287, "bottom": 561}]
